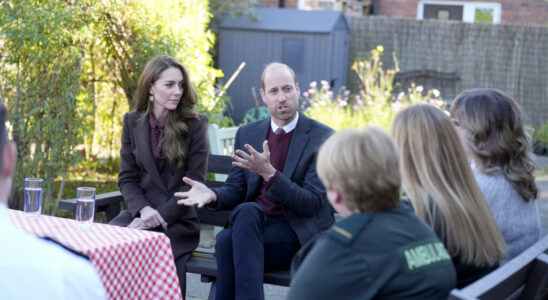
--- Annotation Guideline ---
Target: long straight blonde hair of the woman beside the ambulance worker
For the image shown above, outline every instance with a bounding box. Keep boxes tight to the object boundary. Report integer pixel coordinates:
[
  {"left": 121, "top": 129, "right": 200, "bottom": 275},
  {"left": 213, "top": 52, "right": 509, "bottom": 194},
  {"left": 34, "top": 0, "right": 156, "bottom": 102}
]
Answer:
[{"left": 392, "top": 105, "right": 505, "bottom": 267}]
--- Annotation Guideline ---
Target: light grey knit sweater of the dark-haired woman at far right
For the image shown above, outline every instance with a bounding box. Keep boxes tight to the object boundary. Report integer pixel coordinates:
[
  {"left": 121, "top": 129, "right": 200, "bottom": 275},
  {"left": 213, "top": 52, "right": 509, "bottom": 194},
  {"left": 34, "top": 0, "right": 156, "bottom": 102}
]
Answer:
[{"left": 472, "top": 163, "right": 540, "bottom": 265}]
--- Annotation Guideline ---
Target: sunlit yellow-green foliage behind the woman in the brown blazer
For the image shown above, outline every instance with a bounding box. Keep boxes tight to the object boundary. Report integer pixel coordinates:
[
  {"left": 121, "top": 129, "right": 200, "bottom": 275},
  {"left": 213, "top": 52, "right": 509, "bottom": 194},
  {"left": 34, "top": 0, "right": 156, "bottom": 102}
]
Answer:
[{"left": 0, "top": 0, "right": 223, "bottom": 213}]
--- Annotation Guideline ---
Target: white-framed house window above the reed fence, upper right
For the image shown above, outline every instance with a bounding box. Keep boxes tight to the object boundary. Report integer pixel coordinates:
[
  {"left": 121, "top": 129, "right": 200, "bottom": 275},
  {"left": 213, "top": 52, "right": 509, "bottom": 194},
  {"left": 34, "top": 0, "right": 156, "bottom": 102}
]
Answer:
[{"left": 417, "top": 0, "right": 501, "bottom": 24}]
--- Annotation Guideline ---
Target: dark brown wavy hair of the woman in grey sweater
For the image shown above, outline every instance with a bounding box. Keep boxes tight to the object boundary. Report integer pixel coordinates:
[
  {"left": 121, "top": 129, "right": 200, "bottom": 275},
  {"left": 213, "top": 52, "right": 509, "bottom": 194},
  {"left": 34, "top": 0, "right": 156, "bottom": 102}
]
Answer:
[{"left": 451, "top": 89, "right": 538, "bottom": 202}]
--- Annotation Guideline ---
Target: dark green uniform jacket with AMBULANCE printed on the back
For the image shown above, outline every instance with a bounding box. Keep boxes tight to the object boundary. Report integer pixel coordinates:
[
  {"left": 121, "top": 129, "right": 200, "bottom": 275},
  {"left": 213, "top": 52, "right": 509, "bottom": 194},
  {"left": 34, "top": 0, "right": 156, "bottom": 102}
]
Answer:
[{"left": 287, "top": 201, "right": 456, "bottom": 300}]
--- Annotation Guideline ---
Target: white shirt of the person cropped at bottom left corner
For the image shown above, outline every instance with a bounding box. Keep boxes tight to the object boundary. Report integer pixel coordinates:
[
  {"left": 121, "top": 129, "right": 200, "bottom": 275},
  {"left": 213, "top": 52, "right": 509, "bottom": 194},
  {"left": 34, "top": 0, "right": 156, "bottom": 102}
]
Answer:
[{"left": 0, "top": 203, "right": 107, "bottom": 300}]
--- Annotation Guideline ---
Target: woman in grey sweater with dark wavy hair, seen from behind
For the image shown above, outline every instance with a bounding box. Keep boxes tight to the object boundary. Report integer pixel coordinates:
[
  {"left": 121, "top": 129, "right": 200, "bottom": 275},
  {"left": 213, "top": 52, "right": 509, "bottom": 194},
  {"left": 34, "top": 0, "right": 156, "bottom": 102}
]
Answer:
[{"left": 451, "top": 89, "right": 540, "bottom": 264}]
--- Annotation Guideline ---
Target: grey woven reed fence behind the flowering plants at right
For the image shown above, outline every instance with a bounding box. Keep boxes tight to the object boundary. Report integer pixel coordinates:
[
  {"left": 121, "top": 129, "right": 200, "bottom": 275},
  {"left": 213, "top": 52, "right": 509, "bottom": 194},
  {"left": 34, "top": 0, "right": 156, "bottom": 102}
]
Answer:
[{"left": 347, "top": 16, "right": 548, "bottom": 126}]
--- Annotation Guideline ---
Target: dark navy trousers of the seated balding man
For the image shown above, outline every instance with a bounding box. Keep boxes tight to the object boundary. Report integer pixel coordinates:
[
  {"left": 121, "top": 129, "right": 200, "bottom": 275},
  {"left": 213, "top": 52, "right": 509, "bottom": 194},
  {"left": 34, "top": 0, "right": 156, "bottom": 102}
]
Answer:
[{"left": 215, "top": 202, "right": 300, "bottom": 300}]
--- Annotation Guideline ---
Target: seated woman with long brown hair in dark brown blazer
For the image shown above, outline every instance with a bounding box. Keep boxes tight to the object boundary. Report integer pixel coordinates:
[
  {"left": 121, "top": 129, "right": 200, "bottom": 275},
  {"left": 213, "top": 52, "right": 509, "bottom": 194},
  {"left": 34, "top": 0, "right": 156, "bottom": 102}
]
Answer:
[{"left": 110, "top": 55, "right": 209, "bottom": 296}]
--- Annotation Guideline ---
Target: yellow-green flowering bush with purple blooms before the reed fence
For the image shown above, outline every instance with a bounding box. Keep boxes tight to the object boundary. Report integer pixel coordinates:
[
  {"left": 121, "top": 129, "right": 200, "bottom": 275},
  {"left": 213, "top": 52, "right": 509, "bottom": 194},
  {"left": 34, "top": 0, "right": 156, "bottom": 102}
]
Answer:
[{"left": 303, "top": 46, "right": 445, "bottom": 130}]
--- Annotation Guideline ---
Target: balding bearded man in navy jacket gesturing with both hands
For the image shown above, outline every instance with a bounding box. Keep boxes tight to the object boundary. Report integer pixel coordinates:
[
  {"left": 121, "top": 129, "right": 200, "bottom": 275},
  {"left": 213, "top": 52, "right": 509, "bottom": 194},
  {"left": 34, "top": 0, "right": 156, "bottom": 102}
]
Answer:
[{"left": 179, "top": 63, "right": 333, "bottom": 299}]
